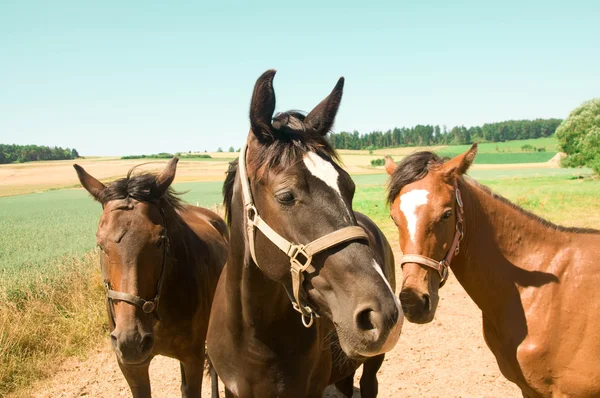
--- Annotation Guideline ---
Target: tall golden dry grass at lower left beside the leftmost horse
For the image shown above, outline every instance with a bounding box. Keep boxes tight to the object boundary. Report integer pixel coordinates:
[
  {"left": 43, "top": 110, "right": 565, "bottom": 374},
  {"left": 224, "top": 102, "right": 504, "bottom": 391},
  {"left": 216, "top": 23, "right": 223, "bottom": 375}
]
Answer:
[{"left": 0, "top": 252, "right": 106, "bottom": 396}]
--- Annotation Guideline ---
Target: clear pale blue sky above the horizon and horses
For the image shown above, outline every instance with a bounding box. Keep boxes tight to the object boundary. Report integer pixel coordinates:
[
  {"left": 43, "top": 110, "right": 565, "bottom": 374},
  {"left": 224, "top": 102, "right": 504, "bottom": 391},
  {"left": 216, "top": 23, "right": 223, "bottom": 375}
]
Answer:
[{"left": 0, "top": 0, "right": 600, "bottom": 155}]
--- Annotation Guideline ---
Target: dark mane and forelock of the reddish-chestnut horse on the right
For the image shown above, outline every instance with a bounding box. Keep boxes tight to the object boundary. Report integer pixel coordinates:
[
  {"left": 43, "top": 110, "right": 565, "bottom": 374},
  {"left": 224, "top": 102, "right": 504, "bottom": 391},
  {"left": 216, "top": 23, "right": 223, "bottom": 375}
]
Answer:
[{"left": 387, "top": 151, "right": 600, "bottom": 234}]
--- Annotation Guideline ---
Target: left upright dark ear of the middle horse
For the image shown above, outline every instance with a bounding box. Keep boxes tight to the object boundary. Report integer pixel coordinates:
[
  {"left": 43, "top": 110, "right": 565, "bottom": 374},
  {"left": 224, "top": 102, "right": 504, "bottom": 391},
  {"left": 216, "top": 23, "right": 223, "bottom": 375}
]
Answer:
[{"left": 250, "top": 69, "right": 276, "bottom": 142}]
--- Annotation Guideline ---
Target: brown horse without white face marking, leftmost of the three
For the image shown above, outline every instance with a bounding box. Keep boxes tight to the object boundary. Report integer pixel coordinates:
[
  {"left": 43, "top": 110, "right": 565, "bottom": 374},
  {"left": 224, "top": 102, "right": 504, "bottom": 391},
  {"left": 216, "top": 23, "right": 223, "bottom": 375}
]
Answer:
[{"left": 74, "top": 158, "right": 228, "bottom": 397}]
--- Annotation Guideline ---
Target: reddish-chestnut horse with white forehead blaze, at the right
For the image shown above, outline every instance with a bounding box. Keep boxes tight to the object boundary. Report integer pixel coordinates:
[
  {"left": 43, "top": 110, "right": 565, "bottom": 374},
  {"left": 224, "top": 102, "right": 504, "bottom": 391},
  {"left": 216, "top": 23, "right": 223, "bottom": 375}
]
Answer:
[{"left": 388, "top": 145, "right": 600, "bottom": 397}]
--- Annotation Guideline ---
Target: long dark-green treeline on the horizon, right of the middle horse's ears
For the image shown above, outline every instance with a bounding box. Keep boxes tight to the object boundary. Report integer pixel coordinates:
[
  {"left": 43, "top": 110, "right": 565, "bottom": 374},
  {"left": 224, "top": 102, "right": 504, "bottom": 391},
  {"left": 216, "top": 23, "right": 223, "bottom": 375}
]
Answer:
[{"left": 329, "top": 119, "right": 562, "bottom": 149}]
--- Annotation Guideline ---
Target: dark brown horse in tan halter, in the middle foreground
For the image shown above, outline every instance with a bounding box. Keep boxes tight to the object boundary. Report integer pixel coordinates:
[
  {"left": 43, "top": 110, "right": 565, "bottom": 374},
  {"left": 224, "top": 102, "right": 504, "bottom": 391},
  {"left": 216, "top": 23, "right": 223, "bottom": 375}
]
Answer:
[{"left": 207, "top": 70, "right": 403, "bottom": 398}]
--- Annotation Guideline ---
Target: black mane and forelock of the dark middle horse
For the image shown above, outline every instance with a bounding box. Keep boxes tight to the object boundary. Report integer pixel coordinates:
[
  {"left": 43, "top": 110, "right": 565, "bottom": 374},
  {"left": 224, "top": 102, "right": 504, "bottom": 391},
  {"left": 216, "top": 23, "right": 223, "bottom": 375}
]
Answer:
[{"left": 223, "top": 110, "right": 341, "bottom": 224}]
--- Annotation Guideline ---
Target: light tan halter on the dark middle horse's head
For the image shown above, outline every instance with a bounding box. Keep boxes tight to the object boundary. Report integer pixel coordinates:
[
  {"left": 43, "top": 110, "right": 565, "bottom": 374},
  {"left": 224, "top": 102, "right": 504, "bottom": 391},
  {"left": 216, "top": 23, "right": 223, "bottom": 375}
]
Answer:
[{"left": 238, "top": 143, "right": 369, "bottom": 328}]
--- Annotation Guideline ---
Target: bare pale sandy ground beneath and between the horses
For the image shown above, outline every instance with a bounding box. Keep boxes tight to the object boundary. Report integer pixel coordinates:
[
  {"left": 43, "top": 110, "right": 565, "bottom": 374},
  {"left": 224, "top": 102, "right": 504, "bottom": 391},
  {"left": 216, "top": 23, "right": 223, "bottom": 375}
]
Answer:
[{"left": 26, "top": 247, "right": 520, "bottom": 398}]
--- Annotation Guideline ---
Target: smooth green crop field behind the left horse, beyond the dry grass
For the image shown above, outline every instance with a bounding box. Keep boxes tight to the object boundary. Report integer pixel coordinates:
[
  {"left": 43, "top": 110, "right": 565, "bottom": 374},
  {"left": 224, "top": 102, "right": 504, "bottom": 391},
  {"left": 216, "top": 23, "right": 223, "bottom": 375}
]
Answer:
[{"left": 0, "top": 181, "right": 223, "bottom": 280}]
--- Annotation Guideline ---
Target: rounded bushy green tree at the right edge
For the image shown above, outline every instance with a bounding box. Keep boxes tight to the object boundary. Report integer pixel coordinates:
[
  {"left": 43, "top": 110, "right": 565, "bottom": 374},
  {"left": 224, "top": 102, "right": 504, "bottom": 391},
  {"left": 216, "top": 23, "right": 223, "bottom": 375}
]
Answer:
[{"left": 556, "top": 98, "right": 600, "bottom": 174}]
